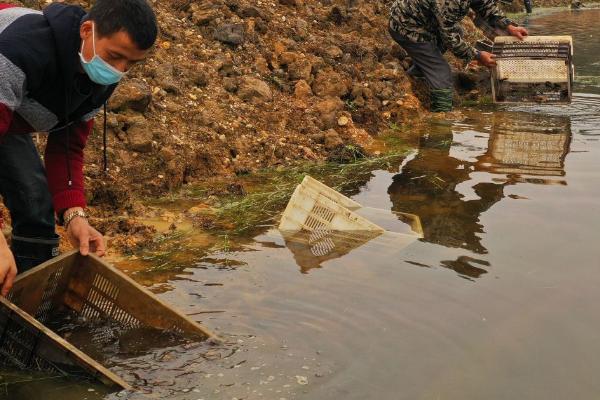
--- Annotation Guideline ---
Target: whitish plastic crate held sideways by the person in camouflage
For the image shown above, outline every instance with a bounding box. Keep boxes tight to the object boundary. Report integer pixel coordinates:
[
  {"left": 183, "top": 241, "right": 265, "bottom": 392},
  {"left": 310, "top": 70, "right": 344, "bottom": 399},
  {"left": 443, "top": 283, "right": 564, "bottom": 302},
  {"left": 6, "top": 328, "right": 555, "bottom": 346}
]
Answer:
[{"left": 492, "top": 36, "right": 574, "bottom": 103}]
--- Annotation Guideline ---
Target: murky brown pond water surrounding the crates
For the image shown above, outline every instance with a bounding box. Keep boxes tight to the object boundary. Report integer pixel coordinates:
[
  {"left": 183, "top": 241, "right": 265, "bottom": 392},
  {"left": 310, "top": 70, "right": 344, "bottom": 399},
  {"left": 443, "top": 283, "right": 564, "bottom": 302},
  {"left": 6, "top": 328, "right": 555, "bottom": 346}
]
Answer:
[{"left": 0, "top": 6, "right": 600, "bottom": 400}]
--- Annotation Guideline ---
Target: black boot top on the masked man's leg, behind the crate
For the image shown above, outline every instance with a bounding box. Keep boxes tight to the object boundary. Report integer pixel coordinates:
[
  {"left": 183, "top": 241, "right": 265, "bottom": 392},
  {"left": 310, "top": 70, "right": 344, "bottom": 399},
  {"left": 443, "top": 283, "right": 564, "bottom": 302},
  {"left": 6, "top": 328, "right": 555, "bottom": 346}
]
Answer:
[{"left": 10, "top": 235, "right": 60, "bottom": 274}]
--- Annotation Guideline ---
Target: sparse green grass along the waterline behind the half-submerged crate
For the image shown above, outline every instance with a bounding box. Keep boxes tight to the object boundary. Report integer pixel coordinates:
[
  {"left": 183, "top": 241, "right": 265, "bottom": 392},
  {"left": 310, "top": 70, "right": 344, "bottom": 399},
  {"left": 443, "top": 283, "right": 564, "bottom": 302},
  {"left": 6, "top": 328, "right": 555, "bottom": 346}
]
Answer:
[{"left": 152, "top": 134, "right": 410, "bottom": 235}]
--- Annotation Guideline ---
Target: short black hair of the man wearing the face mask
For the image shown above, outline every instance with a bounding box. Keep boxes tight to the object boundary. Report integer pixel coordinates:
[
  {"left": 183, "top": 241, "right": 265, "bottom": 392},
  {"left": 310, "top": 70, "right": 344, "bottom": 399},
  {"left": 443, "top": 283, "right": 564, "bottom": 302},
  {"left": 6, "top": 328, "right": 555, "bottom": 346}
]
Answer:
[{"left": 88, "top": 0, "right": 158, "bottom": 50}]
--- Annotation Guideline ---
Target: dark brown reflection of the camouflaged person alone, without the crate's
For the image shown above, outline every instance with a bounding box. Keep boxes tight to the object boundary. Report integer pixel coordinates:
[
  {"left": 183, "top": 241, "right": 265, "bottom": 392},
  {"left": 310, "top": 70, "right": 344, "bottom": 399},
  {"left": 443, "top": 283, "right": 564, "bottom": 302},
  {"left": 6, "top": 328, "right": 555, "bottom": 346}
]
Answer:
[{"left": 388, "top": 127, "right": 504, "bottom": 254}]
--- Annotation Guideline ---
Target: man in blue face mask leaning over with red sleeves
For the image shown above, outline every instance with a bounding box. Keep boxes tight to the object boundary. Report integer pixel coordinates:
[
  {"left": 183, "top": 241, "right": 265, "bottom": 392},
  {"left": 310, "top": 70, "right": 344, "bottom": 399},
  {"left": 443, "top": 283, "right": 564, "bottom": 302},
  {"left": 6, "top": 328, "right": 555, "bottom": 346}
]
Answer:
[{"left": 0, "top": 0, "right": 157, "bottom": 295}]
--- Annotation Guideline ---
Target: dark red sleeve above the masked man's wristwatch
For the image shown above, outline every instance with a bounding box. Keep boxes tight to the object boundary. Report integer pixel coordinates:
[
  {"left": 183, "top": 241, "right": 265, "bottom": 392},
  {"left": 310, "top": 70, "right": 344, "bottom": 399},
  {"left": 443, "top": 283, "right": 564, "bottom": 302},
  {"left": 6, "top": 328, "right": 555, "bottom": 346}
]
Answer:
[{"left": 44, "top": 119, "right": 94, "bottom": 212}]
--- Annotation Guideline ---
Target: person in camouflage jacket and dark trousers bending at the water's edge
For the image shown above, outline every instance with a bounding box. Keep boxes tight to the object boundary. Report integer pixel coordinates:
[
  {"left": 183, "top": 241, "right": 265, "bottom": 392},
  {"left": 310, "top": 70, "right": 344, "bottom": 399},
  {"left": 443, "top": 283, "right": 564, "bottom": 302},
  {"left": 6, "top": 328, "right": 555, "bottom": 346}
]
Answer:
[{"left": 389, "top": 0, "right": 527, "bottom": 112}]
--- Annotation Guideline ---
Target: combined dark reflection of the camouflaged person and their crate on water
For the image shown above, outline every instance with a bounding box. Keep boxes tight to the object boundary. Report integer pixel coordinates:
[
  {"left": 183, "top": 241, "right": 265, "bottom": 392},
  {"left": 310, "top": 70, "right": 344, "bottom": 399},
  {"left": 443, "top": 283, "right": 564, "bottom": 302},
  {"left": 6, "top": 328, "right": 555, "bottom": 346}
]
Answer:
[{"left": 388, "top": 113, "right": 571, "bottom": 262}]
